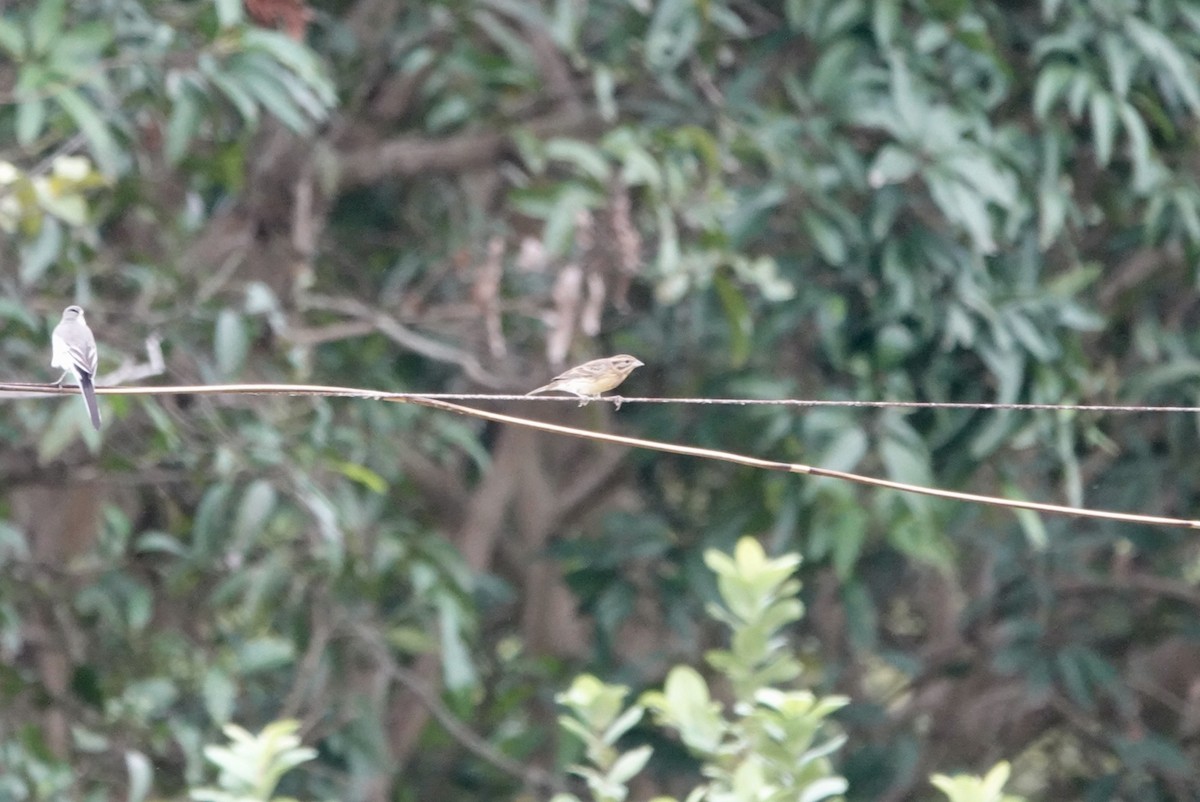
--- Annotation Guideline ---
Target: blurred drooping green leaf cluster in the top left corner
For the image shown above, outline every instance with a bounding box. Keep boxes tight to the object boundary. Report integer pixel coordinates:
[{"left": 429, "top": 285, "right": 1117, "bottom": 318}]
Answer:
[{"left": 0, "top": 0, "right": 335, "bottom": 176}]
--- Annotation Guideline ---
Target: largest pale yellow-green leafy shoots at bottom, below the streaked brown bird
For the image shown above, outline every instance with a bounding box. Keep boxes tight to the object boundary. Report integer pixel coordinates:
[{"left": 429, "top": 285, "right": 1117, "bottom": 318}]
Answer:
[{"left": 556, "top": 538, "right": 847, "bottom": 802}]
